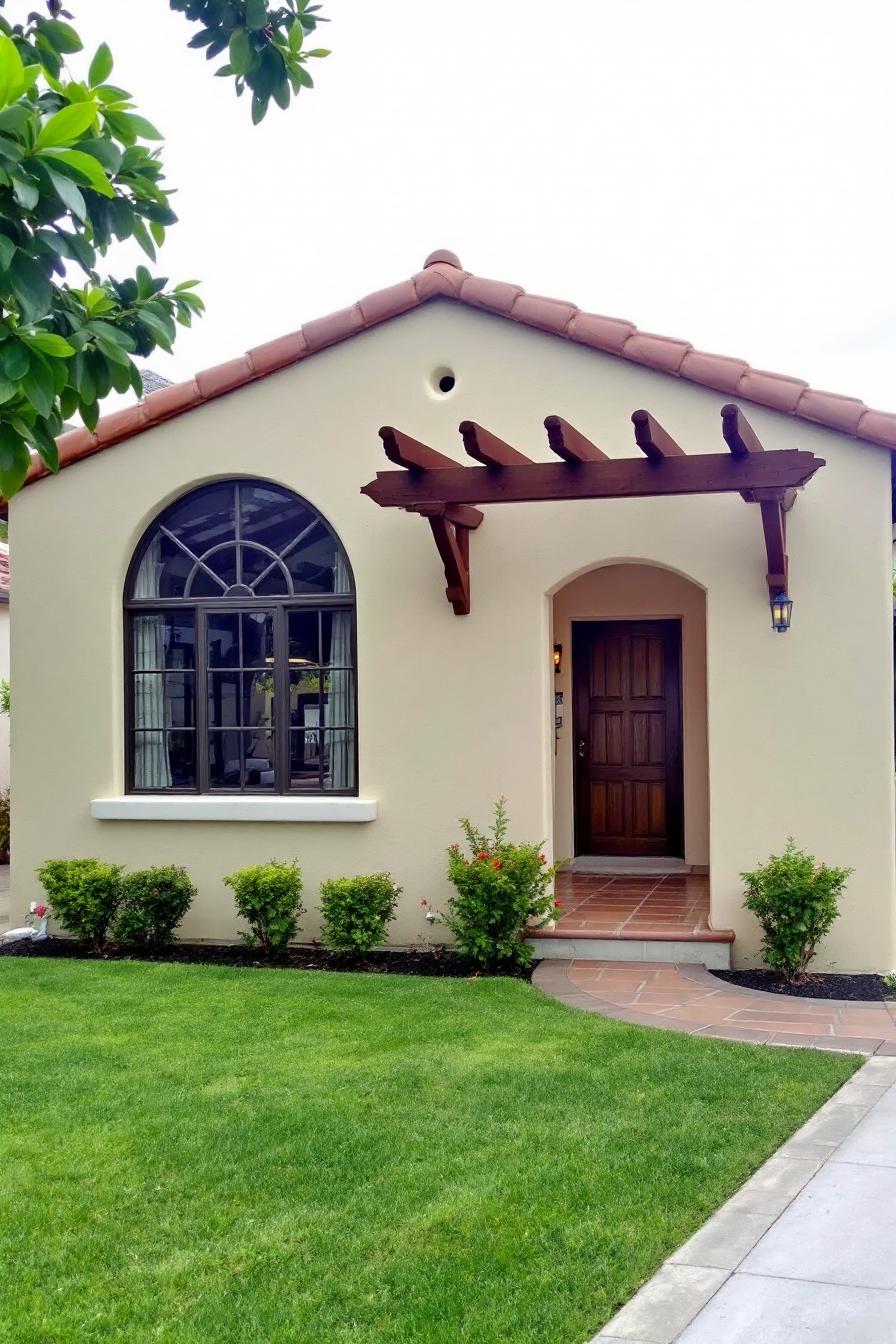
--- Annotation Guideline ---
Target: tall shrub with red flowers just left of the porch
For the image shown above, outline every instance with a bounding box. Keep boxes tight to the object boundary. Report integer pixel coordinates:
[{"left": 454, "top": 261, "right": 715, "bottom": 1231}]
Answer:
[{"left": 441, "top": 798, "right": 556, "bottom": 966}]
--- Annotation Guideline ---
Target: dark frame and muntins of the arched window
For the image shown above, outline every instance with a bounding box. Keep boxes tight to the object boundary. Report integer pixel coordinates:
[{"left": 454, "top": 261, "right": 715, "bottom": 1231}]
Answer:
[{"left": 122, "top": 477, "right": 359, "bottom": 798}]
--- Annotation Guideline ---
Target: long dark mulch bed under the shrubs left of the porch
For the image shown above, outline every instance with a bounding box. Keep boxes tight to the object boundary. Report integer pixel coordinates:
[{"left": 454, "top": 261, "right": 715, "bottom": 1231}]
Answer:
[{"left": 0, "top": 938, "right": 537, "bottom": 980}]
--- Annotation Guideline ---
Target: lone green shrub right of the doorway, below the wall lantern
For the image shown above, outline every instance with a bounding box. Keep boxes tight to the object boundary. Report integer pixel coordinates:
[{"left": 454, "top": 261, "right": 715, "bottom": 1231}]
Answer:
[{"left": 740, "top": 837, "right": 853, "bottom": 980}]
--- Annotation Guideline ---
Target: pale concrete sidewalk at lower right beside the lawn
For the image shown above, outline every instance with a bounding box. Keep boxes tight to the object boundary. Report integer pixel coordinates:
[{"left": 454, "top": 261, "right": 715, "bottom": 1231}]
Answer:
[{"left": 592, "top": 1056, "right": 896, "bottom": 1344}]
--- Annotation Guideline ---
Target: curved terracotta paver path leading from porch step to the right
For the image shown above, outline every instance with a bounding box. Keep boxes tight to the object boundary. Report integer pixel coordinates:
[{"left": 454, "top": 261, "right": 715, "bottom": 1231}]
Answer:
[{"left": 532, "top": 960, "right": 896, "bottom": 1055}]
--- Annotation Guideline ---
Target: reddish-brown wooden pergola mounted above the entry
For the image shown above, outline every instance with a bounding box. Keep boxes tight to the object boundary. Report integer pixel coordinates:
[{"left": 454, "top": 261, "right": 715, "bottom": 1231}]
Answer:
[{"left": 361, "top": 405, "right": 825, "bottom": 616}]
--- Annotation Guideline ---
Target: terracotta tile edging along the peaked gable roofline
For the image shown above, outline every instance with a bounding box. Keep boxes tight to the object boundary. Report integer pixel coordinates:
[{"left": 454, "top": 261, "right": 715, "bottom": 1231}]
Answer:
[{"left": 17, "top": 249, "right": 896, "bottom": 494}]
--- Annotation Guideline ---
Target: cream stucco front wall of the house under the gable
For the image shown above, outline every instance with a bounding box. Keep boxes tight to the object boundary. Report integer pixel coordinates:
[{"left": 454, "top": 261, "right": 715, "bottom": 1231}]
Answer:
[{"left": 11, "top": 301, "right": 896, "bottom": 969}]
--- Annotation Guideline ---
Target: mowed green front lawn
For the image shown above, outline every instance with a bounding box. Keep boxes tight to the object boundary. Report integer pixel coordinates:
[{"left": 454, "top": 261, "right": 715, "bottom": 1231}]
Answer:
[{"left": 0, "top": 958, "right": 857, "bottom": 1344}]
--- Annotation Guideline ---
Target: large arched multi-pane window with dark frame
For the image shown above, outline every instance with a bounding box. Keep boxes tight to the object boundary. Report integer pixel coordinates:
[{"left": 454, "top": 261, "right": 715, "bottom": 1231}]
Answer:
[{"left": 125, "top": 480, "right": 357, "bottom": 793}]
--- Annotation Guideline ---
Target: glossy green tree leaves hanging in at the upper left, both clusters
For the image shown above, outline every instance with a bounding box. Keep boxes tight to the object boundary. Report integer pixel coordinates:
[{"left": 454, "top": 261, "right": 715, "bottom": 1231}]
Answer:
[{"left": 0, "top": 0, "right": 326, "bottom": 499}]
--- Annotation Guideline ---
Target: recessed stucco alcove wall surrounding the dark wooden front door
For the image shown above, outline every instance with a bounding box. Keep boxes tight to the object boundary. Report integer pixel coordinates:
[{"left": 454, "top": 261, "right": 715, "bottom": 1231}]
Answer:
[{"left": 552, "top": 564, "right": 709, "bottom": 868}]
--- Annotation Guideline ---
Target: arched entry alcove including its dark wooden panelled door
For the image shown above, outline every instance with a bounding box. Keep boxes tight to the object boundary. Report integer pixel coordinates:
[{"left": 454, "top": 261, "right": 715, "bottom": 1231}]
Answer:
[{"left": 552, "top": 562, "right": 709, "bottom": 872}]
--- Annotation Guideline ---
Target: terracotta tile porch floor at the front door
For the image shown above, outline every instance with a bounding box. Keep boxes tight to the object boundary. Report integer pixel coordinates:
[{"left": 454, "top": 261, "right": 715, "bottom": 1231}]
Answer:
[{"left": 544, "top": 872, "right": 713, "bottom": 941}]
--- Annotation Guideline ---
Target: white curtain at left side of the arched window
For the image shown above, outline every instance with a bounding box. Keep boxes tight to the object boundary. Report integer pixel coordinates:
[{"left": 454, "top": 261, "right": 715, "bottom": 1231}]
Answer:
[{"left": 133, "top": 538, "right": 171, "bottom": 789}]
